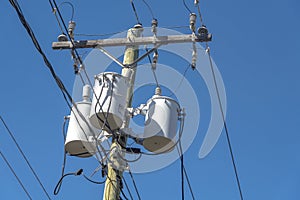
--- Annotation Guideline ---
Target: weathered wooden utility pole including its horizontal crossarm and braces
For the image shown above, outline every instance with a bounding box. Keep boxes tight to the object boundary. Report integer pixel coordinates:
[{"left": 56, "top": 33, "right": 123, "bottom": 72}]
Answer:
[{"left": 52, "top": 19, "right": 212, "bottom": 200}]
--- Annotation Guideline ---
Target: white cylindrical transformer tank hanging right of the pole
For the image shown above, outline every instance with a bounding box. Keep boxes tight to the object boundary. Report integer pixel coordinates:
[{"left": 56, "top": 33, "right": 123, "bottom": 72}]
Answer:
[{"left": 143, "top": 95, "right": 180, "bottom": 153}]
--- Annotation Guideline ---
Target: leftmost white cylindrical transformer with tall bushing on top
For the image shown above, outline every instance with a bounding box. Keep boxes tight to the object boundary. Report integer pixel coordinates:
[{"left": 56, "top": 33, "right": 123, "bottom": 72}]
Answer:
[{"left": 65, "top": 85, "right": 99, "bottom": 157}]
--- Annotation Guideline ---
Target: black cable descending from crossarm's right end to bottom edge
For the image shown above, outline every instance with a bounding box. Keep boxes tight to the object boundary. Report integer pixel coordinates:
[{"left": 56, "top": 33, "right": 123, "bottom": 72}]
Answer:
[{"left": 206, "top": 43, "right": 244, "bottom": 200}]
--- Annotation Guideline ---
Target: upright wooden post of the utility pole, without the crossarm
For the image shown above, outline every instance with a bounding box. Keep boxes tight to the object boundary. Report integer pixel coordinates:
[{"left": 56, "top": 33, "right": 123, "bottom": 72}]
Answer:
[{"left": 103, "top": 25, "right": 143, "bottom": 200}]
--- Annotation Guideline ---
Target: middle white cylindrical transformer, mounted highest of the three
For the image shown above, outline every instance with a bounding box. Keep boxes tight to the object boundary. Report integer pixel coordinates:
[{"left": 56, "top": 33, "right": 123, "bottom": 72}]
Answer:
[{"left": 90, "top": 72, "right": 129, "bottom": 130}]
